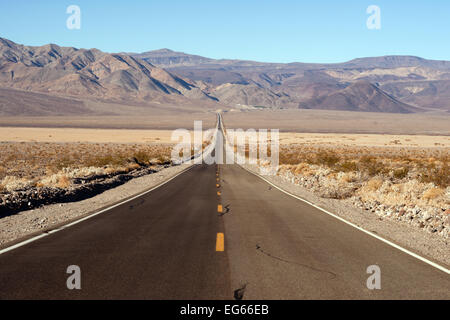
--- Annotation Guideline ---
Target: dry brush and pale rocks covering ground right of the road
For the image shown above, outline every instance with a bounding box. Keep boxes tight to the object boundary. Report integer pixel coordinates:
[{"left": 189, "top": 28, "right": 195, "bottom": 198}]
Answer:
[{"left": 278, "top": 144, "right": 450, "bottom": 237}]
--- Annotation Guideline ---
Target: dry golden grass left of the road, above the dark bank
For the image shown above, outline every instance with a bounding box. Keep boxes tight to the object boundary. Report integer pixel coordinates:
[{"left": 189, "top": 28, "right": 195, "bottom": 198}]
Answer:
[{"left": 0, "top": 142, "right": 172, "bottom": 192}]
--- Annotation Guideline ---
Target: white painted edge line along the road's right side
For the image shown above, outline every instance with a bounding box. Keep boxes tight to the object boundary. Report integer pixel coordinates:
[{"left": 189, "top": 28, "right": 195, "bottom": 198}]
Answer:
[{"left": 240, "top": 166, "right": 450, "bottom": 274}]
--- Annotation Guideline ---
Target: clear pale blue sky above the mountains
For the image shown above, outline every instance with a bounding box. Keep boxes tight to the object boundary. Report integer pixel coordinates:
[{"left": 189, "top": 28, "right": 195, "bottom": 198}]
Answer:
[{"left": 0, "top": 0, "right": 450, "bottom": 62}]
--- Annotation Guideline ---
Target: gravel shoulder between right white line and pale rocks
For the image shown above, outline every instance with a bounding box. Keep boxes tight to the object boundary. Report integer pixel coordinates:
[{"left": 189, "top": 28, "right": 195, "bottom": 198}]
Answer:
[{"left": 243, "top": 164, "right": 450, "bottom": 268}]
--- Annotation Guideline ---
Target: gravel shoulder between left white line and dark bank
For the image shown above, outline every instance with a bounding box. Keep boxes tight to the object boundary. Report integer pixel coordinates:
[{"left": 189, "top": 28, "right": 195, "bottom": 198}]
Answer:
[{"left": 0, "top": 164, "right": 191, "bottom": 248}]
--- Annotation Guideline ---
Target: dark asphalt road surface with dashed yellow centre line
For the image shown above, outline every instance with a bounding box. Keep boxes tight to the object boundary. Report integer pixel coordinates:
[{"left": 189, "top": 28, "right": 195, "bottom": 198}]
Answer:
[{"left": 0, "top": 121, "right": 450, "bottom": 300}]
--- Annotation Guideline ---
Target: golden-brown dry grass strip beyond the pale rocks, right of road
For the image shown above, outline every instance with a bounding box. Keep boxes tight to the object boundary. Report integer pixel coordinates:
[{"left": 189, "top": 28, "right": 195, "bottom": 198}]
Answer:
[{"left": 280, "top": 145, "right": 450, "bottom": 188}]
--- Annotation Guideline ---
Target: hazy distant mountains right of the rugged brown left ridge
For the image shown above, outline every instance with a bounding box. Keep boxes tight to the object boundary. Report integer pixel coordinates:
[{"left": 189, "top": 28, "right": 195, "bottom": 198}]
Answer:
[{"left": 138, "top": 50, "right": 450, "bottom": 113}]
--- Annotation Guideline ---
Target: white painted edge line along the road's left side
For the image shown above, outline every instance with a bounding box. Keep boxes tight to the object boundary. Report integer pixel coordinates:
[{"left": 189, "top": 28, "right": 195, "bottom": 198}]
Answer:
[{"left": 0, "top": 164, "right": 193, "bottom": 255}]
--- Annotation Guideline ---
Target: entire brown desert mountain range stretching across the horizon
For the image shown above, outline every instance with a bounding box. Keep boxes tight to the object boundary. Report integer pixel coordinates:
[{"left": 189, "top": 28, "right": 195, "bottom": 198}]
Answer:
[{"left": 0, "top": 38, "right": 450, "bottom": 115}]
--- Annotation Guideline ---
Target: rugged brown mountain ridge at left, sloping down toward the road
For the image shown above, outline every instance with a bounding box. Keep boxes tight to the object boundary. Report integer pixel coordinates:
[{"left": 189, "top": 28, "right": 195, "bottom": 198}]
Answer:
[{"left": 0, "top": 38, "right": 215, "bottom": 111}]
